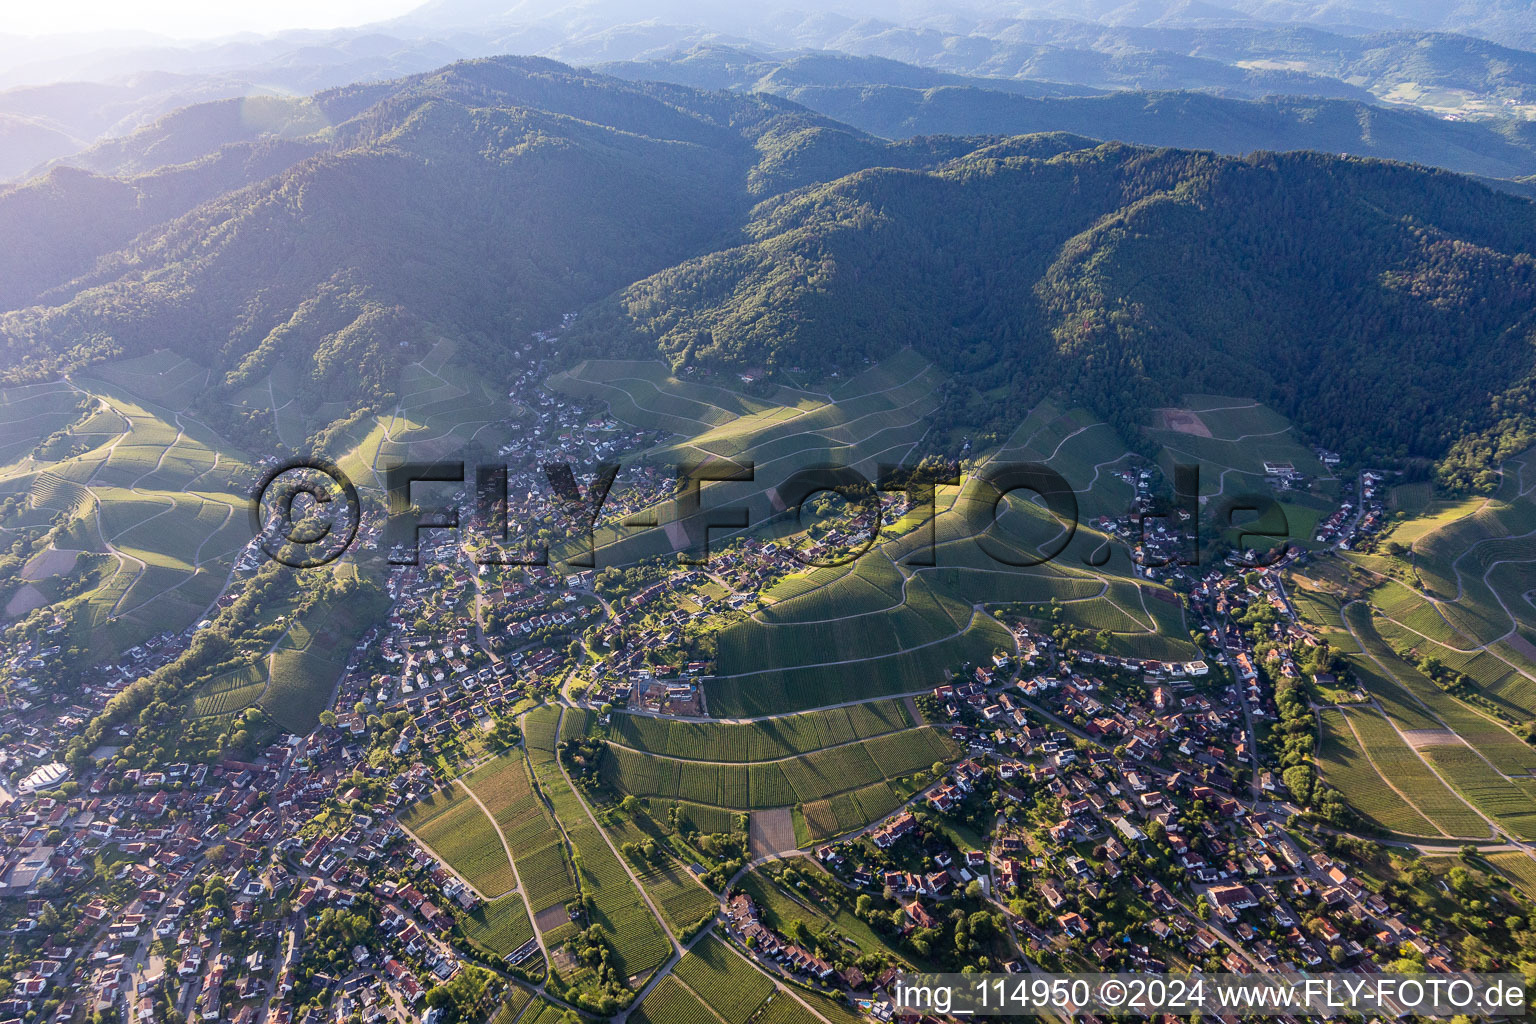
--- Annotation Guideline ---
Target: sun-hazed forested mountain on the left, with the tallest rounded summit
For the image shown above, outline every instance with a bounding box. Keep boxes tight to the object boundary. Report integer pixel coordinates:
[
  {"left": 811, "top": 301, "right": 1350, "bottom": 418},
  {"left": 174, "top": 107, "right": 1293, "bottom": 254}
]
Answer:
[{"left": 0, "top": 58, "right": 972, "bottom": 423}]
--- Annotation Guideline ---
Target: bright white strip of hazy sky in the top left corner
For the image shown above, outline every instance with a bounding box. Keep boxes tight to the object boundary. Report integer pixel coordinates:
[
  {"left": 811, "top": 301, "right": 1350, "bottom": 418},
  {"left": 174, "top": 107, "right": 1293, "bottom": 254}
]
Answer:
[{"left": 0, "top": 0, "right": 421, "bottom": 37}]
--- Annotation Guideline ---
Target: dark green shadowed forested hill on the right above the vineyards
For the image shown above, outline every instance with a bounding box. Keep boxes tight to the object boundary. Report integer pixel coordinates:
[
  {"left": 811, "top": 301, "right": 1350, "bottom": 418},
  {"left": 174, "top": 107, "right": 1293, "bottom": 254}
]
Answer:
[{"left": 559, "top": 144, "right": 1536, "bottom": 484}]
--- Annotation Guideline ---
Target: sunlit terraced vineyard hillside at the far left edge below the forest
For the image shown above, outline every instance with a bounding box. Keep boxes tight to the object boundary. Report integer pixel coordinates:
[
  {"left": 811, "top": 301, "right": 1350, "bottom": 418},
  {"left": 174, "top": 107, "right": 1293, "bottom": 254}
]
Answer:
[{"left": 0, "top": 353, "right": 252, "bottom": 657}]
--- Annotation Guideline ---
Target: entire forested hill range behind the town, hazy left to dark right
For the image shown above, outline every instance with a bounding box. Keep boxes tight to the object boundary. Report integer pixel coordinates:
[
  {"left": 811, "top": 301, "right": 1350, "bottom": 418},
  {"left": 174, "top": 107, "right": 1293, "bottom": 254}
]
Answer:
[{"left": 0, "top": 58, "right": 1536, "bottom": 482}]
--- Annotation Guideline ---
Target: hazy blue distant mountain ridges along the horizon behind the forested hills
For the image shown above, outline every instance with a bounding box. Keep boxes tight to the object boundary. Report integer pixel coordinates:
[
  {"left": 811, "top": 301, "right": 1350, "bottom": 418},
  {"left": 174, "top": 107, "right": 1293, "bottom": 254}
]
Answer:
[{"left": 14, "top": 0, "right": 1536, "bottom": 180}]
